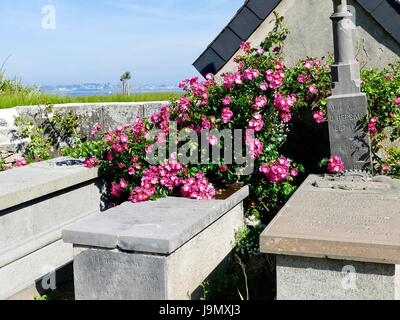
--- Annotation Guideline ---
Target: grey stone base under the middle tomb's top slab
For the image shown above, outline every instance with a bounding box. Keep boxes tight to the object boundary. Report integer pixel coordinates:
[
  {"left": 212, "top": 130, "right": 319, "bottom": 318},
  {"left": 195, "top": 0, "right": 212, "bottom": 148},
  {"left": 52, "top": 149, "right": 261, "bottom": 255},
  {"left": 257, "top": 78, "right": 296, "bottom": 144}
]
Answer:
[{"left": 69, "top": 204, "right": 243, "bottom": 300}]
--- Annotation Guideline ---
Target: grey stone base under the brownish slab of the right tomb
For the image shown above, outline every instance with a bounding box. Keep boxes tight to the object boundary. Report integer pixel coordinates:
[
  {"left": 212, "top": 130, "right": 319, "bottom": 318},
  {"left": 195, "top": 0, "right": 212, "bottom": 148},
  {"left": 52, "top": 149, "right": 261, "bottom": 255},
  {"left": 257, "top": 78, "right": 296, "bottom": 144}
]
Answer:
[{"left": 276, "top": 256, "right": 400, "bottom": 300}]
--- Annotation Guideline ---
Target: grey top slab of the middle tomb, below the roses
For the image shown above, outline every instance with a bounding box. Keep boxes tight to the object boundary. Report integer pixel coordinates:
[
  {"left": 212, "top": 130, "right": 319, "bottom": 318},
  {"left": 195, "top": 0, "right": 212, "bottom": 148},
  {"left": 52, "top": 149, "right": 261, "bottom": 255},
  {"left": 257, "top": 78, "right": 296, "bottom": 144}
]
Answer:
[{"left": 63, "top": 187, "right": 249, "bottom": 255}]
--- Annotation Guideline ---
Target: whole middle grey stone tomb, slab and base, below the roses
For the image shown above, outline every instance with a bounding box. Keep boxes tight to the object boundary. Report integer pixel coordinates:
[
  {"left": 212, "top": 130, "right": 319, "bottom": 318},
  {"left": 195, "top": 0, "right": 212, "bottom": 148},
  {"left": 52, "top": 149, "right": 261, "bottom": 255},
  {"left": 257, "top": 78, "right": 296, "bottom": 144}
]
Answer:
[{"left": 63, "top": 187, "right": 249, "bottom": 300}]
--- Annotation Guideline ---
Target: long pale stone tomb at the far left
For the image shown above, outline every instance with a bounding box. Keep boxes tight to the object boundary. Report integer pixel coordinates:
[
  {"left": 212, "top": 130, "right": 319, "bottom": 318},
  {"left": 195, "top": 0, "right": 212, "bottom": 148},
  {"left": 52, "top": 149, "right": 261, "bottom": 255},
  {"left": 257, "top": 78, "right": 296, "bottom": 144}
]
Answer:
[{"left": 0, "top": 158, "right": 103, "bottom": 299}]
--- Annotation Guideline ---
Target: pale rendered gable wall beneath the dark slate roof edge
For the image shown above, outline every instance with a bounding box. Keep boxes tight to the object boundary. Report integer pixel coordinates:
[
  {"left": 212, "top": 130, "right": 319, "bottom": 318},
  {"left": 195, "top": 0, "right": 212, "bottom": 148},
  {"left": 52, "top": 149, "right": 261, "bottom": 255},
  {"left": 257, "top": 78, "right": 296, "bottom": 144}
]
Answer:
[{"left": 219, "top": 0, "right": 400, "bottom": 74}]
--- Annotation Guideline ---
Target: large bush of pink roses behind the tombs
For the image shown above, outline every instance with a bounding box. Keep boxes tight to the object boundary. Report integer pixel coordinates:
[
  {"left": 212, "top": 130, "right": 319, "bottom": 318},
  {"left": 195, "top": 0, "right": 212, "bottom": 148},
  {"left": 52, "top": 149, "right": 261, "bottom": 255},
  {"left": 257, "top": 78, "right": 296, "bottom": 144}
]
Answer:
[{"left": 59, "top": 18, "right": 400, "bottom": 220}]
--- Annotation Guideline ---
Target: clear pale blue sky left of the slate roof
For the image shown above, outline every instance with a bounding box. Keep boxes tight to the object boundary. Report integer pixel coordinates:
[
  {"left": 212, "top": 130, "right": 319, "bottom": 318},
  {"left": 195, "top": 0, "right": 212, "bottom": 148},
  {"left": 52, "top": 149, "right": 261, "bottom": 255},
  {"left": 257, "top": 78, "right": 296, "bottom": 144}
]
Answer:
[{"left": 0, "top": 0, "right": 244, "bottom": 85}]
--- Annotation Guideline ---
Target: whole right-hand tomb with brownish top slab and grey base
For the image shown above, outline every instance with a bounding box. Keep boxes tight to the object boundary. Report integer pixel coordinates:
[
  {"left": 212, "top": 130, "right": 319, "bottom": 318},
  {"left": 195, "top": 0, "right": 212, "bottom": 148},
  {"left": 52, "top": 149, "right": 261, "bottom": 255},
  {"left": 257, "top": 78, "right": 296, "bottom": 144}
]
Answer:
[{"left": 260, "top": 174, "right": 400, "bottom": 300}]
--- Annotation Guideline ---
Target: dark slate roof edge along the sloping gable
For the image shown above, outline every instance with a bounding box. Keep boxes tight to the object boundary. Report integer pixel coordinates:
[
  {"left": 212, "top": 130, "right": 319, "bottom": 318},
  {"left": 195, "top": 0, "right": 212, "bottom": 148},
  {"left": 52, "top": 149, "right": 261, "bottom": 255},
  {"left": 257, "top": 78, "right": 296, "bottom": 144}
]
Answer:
[{"left": 193, "top": 0, "right": 400, "bottom": 76}]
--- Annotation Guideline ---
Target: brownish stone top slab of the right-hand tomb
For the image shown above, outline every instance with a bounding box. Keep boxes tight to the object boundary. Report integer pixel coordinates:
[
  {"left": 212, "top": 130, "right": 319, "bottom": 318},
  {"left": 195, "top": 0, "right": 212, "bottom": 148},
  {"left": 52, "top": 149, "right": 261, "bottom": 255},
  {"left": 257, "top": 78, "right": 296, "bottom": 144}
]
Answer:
[{"left": 261, "top": 175, "right": 400, "bottom": 264}]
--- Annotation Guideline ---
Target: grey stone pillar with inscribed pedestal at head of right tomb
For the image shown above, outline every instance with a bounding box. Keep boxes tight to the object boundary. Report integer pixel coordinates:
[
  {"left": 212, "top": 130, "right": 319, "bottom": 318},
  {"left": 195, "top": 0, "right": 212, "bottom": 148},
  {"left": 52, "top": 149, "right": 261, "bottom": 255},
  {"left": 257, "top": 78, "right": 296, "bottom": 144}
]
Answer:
[{"left": 328, "top": 0, "right": 372, "bottom": 171}]
